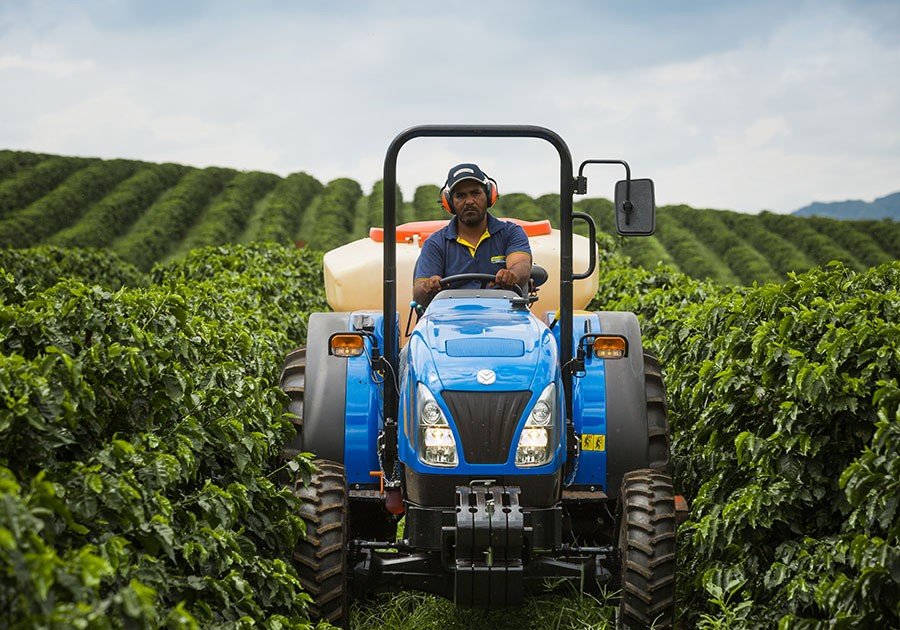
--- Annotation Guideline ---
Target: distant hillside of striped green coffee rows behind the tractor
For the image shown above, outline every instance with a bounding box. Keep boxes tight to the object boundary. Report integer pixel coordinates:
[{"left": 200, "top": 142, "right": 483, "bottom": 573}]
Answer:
[{"left": 0, "top": 150, "right": 900, "bottom": 285}]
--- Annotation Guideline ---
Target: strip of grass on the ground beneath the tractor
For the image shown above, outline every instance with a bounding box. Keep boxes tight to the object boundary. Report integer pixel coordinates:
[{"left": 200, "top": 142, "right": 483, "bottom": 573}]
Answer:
[{"left": 350, "top": 589, "right": 616, "bottom": 630}]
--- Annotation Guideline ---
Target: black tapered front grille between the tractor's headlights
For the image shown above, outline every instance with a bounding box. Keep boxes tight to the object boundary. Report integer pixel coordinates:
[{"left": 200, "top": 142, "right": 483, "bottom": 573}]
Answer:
[{"left": 441, "top": 390, "right": 531, "bottom": 464}]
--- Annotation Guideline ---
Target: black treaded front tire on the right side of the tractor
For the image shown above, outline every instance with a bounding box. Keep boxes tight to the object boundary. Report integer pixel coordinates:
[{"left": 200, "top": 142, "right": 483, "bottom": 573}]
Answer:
[{"left": 618, "top": 469, "right": 675, "bottom": 629}]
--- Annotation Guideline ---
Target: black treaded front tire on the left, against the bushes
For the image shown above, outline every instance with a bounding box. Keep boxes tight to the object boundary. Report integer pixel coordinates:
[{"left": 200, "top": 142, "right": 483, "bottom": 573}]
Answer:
[{"left": 293, "top": 459, "right": 349, "bottom": 626}]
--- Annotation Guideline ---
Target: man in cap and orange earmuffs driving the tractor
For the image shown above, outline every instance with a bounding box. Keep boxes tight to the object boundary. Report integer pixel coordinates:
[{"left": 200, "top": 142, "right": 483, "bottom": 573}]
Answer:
[{"left": 413, "top": 163, "right": 531, "bottom": 306}]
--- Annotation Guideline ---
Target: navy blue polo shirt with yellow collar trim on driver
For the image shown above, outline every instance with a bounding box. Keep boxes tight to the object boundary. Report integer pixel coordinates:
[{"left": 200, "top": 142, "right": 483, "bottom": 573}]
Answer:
[{"left": 413, "top": 213, "right": 531, "bottom": 289}]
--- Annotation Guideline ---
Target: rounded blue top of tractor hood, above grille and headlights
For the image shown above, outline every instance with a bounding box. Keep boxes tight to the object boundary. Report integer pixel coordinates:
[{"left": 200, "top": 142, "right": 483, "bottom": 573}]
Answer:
[{"left": 409, "top": 291, "right": 558, "bottom": 393}]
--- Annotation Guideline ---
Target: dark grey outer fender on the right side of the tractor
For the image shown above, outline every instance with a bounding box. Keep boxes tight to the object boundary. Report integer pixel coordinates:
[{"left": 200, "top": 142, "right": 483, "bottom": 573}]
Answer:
[{"left": 596, "top": 311, "right": 650, "bottom": 498}]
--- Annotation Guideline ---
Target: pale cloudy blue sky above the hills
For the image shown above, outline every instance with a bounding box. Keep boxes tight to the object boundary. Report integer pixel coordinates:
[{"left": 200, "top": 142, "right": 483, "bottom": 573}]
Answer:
[{"left": 0, "top": 0, "right": 900, "bottom": 212}]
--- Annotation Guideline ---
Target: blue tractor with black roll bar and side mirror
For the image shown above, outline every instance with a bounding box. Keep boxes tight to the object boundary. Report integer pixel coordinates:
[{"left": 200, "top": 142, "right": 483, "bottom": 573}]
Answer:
[{"left": 282, "top": 125, "right": 677, "bottom": 628}]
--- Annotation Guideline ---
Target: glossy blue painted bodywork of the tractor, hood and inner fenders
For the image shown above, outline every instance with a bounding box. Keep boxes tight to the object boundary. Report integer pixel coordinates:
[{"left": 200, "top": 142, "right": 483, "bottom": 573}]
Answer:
[{"left": 335, "top": 302, "right": 607, "bottom": 488}]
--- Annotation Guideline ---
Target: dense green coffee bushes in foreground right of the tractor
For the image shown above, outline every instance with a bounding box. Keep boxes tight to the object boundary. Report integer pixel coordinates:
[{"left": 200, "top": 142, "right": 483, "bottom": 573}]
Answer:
[{"left": 600, "top": 262, "right": 900, "bottom": 627}]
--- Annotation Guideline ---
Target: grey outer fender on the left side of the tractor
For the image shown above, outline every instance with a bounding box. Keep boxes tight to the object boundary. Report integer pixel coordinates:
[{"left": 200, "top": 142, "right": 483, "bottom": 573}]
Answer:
[{"left": 302, "top": 313, "right": 350, "bottom": 464}]
